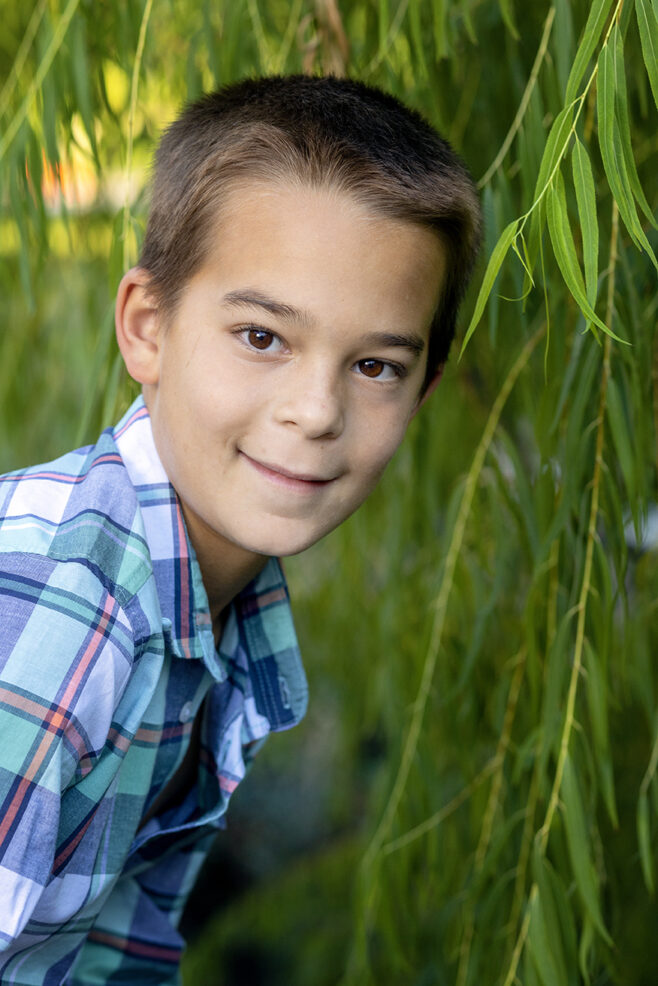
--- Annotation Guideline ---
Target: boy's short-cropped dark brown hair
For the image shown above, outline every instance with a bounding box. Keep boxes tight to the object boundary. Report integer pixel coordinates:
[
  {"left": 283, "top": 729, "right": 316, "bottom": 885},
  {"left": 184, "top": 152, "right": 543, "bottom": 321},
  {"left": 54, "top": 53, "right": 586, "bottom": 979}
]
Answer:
[{"left": 140, "top": 75, "right": 480, "bottom": 380}]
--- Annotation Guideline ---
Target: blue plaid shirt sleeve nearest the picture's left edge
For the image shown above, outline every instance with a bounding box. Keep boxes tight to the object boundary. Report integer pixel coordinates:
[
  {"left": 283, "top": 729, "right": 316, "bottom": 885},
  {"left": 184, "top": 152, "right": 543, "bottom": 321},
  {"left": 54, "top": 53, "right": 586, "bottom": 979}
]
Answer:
[{"left": 0, "top": 553, "right": 130, "bottom": 948}]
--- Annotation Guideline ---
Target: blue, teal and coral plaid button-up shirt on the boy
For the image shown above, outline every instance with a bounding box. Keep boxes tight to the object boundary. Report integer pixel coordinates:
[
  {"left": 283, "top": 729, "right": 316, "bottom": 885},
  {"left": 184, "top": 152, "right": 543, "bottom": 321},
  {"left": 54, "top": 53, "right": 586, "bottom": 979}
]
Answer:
[{"left": 0, "top": 398, "right": 306, "bottom": 986}]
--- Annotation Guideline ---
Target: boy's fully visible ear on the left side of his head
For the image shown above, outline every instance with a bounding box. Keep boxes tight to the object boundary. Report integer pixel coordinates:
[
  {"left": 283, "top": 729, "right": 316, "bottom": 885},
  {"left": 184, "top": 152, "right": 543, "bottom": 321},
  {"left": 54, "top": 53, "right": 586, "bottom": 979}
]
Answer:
[{"left": 114, "top": 267, "right": 161, "bottom": 387}]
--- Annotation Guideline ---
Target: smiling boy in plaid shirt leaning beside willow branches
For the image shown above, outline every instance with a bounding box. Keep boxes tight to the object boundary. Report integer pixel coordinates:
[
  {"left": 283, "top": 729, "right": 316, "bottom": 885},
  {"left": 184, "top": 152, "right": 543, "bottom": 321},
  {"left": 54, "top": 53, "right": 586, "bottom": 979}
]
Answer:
[{"left": 0, "top": 77, "right": 479, "bottom": 986}]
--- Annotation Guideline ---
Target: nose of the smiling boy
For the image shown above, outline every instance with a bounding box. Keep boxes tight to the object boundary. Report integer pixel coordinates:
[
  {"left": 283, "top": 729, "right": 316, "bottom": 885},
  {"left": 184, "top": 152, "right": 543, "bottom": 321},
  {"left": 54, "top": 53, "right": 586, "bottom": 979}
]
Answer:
[{"left": 277, "top": 365, "right": 345, "bottom": 439}]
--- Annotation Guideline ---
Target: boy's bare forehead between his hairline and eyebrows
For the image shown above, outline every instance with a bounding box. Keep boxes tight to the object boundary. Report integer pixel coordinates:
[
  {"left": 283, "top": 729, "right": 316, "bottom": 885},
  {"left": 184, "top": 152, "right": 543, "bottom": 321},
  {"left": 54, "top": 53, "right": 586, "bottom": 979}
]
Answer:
[{"left": 193, "top": 181, "right": 445, "bottom": 334}]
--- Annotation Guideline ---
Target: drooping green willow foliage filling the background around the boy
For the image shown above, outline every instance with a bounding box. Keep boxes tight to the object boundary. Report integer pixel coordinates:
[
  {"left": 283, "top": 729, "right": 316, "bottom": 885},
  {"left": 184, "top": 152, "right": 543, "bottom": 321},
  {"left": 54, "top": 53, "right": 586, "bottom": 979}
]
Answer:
[{"left": 0, "top": 0, "right": 658, "bottom": 986}]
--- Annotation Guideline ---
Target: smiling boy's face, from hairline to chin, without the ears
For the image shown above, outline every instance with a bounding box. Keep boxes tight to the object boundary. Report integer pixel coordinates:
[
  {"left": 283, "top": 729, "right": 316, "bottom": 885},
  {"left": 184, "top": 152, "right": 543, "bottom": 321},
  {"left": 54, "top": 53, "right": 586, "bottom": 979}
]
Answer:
[{"left": 129, "top": 183, "right": 443, "bottom": 569}]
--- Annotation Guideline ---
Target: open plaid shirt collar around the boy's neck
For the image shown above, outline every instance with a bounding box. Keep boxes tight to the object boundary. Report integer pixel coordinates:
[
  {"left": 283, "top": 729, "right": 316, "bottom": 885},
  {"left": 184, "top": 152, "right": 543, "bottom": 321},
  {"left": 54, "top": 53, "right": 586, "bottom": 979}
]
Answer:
[{"left": 113, "top": 396, "right": 307, "bottom": 729}]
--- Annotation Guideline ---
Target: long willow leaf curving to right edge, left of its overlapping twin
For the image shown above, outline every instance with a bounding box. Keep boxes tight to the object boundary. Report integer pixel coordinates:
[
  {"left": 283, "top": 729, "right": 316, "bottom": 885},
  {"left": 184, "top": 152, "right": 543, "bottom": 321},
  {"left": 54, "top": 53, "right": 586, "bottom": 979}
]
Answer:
[{"left": 596, "top": 32, "right": 658, "bottom": 267}]
